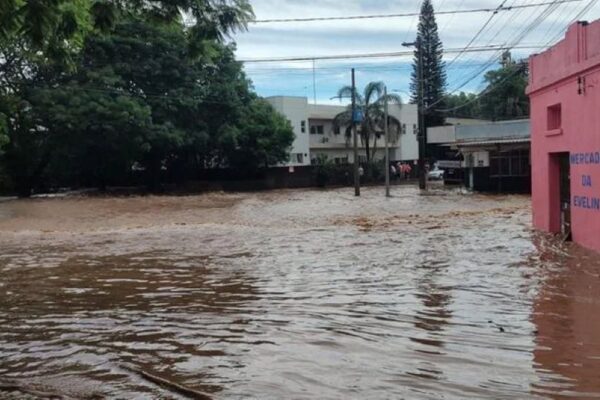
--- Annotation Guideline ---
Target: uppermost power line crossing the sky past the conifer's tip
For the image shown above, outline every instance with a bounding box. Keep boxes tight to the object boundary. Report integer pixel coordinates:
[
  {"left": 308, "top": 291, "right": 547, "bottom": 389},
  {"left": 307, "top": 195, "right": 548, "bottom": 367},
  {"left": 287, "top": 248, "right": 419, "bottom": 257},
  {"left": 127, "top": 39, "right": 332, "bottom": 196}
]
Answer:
[{"left": 253, "top": 0, "right": 582, "bottom": 24}]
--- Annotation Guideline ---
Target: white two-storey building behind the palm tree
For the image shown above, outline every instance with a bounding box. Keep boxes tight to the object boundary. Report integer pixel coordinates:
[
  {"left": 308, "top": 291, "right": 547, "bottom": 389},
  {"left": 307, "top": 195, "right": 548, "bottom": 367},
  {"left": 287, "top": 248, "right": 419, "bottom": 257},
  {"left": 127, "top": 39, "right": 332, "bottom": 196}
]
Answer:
[{"left": 267, "top": 96, "right": 419, "bottom": 166}]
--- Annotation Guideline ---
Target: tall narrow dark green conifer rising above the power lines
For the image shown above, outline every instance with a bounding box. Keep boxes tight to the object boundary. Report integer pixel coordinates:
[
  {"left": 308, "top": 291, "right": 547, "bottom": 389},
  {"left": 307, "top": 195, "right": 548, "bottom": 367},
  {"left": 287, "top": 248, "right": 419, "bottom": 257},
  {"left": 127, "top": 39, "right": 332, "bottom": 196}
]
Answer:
[{"left": 410, "top": 0, "right": 446, "bottom": 127}]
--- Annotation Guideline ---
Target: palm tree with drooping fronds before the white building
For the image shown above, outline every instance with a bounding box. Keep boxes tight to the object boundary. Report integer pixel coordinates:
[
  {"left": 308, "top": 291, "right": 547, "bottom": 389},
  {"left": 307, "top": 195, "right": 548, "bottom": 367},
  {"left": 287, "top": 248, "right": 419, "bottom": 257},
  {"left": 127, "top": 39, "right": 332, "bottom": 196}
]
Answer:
[{"left": 333, "top": 82, "right": 402, "bottom": 162}]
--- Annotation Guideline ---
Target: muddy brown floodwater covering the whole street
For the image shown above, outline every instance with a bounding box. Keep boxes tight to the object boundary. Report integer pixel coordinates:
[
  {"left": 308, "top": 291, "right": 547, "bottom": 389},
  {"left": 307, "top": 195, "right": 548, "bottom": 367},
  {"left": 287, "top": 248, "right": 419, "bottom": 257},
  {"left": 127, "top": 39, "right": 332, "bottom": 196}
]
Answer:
[{"left": 0, "top": 187, "right": 600, "bottom": 399}]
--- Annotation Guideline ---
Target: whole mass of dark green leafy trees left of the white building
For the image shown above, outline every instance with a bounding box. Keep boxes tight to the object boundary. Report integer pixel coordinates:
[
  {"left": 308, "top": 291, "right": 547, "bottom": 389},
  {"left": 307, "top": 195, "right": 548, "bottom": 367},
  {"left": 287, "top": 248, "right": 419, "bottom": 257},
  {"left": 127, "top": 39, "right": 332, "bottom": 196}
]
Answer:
[{"left": 0, "top": 0, "right": 294, "bottom": 196}]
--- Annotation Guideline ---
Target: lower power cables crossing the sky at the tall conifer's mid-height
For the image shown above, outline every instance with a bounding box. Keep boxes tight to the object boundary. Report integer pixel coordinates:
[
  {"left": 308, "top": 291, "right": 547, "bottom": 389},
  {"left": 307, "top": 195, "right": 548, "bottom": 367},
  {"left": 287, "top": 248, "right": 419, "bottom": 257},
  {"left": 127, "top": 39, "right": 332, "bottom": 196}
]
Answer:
[{"left": 238, "top": 44, "right": 544, "bottom": 64}]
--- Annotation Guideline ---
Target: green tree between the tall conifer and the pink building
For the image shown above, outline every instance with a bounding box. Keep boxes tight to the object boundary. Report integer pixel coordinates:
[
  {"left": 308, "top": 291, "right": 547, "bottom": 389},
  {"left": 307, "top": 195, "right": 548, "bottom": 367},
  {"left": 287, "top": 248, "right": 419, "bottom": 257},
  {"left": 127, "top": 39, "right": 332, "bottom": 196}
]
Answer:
[{"left": 480, "top": 61, "right": 529, "bottom": 120}]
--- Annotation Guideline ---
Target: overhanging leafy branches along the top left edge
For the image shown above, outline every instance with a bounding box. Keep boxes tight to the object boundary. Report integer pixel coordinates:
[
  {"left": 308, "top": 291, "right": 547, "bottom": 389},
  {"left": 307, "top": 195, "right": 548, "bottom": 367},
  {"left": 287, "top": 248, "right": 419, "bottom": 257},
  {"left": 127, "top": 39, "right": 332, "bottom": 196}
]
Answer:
[{"left": 0, "top": 0, "right": 254, "bottom": 50}]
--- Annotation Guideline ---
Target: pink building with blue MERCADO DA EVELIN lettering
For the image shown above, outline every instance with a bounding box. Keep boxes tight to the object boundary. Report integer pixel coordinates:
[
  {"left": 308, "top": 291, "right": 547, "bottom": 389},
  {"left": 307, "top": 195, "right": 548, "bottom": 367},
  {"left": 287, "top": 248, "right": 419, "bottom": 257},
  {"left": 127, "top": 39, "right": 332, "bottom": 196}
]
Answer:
[{"left": 528, "top": 20, "right": 600, "bottom": 251}]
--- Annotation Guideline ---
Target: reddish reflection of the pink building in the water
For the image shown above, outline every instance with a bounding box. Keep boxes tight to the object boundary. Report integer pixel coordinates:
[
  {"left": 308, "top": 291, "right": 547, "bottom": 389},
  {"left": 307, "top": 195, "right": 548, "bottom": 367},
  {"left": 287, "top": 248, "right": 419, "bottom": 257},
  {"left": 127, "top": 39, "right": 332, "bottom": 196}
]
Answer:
[{"left": 532, "top": 237, "right": 600, "bottom": 399}]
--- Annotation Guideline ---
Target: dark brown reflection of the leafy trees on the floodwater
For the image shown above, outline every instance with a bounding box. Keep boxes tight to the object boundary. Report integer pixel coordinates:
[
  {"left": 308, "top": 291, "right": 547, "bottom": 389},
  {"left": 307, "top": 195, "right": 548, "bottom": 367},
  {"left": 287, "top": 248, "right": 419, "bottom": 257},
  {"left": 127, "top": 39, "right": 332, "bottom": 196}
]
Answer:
[{"left": 0, "top": 251, "right": 257, "bottom": 398}]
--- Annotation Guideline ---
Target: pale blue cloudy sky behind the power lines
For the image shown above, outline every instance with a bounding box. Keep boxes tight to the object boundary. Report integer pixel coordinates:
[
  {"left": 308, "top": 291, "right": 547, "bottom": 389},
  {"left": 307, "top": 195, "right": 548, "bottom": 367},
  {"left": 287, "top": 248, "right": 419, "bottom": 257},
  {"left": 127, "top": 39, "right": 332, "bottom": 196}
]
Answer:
[{"left": 233, "top": 0, "right": 600, "bottom": 103}]
